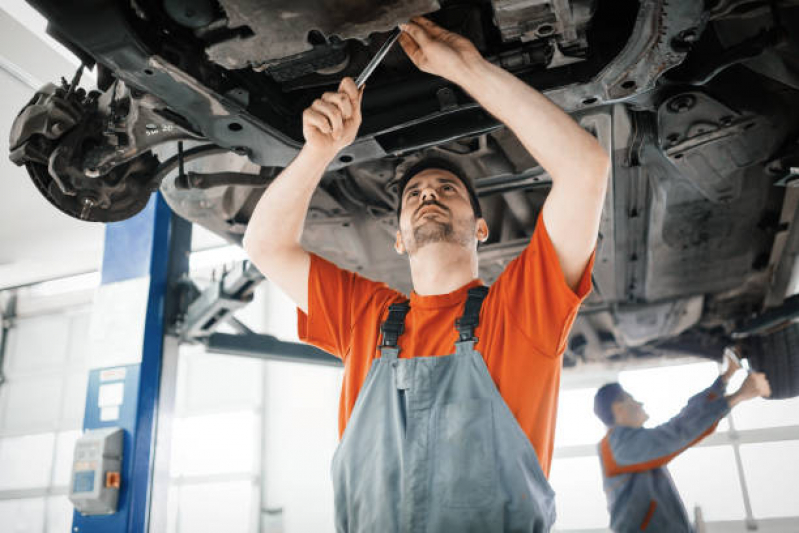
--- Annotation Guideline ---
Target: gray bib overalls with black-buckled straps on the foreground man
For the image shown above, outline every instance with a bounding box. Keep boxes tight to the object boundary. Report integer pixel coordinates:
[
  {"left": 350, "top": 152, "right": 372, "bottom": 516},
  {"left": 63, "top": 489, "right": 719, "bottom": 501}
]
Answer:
[{"left": 332, "top": 287, "right": 555, "bottom": 533}]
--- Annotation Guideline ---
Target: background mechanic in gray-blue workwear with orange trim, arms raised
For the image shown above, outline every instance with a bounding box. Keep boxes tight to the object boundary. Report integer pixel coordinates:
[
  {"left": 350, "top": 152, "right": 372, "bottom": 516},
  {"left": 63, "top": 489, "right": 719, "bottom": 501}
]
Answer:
[{"left": 594, "top": 357, "right": 771, "bottom": 533}]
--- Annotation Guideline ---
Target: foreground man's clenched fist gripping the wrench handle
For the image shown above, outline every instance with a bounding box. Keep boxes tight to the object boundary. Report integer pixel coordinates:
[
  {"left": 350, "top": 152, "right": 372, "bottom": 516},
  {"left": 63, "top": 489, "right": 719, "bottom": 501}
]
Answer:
[{"left": 302, "top": 78, "right": 363, "bottom": 158}]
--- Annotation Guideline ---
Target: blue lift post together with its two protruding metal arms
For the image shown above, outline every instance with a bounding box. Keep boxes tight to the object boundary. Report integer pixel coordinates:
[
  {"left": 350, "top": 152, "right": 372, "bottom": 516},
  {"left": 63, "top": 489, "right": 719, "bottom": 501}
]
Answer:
[{"left": 72, "top": 189, "right": 341, "bottom": 533}]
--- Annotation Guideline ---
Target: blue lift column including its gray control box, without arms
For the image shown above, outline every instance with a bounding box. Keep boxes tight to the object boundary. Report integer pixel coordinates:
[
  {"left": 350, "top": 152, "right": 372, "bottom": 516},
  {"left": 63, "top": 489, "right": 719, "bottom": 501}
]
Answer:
[{"left": 70, "top": 193, "right": 191, "bottom": 533}]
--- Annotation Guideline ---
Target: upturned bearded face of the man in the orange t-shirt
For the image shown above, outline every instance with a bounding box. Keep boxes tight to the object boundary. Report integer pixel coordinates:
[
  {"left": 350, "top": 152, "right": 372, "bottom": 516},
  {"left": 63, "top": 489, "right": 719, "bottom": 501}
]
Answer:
[{"left": 398, "top": 168, "right": 484, "bottom": 255}]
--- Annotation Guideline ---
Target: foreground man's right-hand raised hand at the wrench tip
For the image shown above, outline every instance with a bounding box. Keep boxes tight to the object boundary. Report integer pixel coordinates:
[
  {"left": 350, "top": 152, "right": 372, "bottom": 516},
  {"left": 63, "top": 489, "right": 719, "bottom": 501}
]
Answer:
[{"left": 399, "top": 17, "right": 483, "bottom": 83}]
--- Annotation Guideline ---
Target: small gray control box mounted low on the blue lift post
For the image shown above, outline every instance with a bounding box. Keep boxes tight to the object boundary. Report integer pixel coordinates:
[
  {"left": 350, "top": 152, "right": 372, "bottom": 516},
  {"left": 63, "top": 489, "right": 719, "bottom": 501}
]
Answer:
[{"left": 69, "top": 427, "right": 124, "bottom": 515}]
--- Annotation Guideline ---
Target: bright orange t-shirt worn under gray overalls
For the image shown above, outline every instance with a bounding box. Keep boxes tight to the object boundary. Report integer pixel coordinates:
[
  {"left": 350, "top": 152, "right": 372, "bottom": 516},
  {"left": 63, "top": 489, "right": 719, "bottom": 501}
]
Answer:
[{"left": 298, "top": 215, "right": 594, "bottom": 475}]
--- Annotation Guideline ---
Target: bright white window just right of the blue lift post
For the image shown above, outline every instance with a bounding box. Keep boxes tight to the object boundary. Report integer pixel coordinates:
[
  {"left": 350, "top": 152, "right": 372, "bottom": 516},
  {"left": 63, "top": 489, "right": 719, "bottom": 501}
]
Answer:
[{"left": 167, "top": 345, "right": 264, "bottom": 533}]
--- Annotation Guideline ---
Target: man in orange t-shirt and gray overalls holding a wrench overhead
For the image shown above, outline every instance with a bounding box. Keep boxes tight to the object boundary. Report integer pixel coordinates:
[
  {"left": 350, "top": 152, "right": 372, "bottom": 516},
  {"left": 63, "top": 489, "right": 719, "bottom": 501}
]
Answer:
[{"left": 244, "top": 17, "right": 609, "bottom": 532}]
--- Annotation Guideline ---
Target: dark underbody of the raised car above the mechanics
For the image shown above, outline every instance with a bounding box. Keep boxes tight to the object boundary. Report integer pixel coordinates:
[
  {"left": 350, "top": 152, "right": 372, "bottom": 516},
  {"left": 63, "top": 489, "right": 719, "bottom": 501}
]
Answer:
[{"left": 4, "top": 0, "right": 799, "bottom": 384}]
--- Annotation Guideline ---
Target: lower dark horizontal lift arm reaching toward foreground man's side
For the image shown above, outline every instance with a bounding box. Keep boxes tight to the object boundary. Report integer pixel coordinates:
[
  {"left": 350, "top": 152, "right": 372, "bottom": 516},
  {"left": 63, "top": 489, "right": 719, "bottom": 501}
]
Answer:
[{"left": 205, "top": 333, "right": 342, "bottom": 366}]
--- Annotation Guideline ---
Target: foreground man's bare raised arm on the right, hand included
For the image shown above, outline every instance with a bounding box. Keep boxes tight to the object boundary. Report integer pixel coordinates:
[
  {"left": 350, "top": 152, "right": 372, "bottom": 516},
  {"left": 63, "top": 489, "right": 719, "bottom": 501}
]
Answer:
[{"left": 400, "top": 17, "right": 610, "bottom": 289}]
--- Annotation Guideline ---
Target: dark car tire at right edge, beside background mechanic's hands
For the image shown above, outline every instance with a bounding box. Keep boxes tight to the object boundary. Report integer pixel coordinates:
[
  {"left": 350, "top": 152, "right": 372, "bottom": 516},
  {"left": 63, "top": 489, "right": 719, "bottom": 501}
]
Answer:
[{"left": 745, "top": 323, "right": 799, "bottom": 400}]
